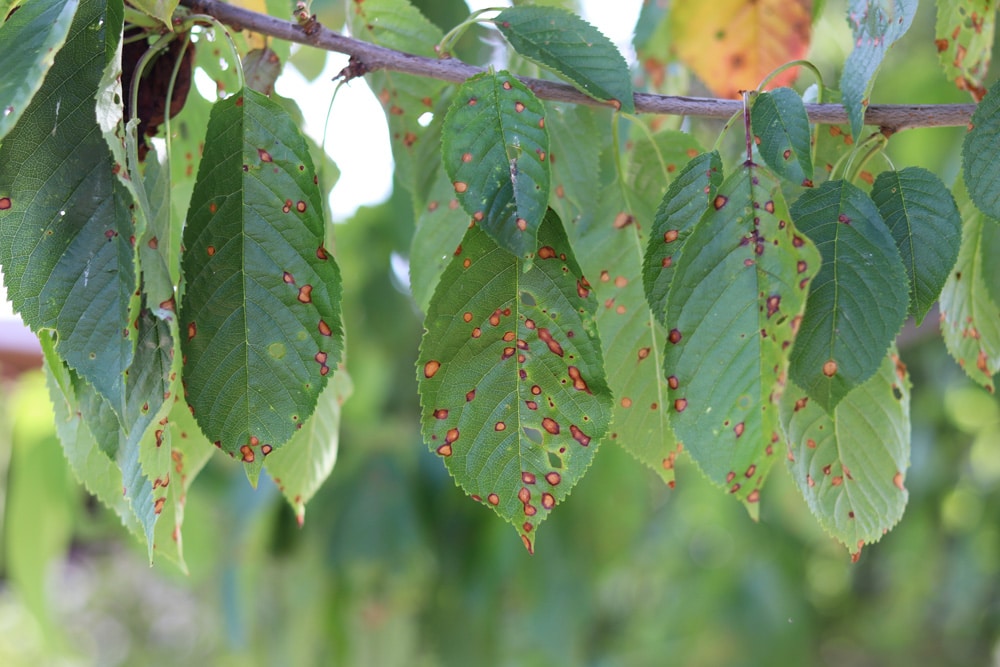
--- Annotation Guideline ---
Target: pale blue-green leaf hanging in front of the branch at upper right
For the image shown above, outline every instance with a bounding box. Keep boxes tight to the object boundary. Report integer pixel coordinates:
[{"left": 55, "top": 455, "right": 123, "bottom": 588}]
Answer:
[{"left": 840, "top": 0, "right": 917, "bottom": 140}]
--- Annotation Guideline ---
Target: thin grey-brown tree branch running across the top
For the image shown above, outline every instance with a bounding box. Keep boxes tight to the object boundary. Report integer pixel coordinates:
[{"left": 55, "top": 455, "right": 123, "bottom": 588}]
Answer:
[{"left": 180, "top": 0, "right": 976, "bottom": 134}]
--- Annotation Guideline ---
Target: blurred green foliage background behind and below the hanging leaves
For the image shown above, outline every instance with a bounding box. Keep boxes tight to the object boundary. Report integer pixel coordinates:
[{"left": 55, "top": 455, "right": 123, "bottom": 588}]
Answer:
[{"left": 0, "top": 0, "right": 1000, "bottom": 667}]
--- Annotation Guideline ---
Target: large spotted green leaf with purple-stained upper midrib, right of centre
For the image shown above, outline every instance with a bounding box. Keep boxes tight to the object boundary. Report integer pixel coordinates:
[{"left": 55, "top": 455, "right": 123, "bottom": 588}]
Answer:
[{"left": 663, "top": 163, "right": 820, "bottom": 516}]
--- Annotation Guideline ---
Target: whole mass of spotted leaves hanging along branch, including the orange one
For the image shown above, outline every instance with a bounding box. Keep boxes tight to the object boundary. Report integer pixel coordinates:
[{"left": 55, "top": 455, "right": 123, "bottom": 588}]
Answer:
[{"left": 0, "top": 0, "right": 1000, "bottom": 559}]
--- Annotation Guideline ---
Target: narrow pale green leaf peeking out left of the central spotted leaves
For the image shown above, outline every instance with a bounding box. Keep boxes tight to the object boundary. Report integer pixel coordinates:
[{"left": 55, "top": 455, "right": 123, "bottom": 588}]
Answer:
[{"left": 410, "top": 169, "right": 471, "bottom": 312}]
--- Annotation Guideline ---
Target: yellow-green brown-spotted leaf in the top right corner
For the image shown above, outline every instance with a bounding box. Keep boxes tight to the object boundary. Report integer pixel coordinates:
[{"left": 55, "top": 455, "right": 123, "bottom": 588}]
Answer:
[{"left": 934, "top": 0, "right": 997, "bottom": 102}]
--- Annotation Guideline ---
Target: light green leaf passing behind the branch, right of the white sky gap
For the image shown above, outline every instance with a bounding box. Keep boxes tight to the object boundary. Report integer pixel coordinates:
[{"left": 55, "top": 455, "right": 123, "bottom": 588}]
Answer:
[{"left": 347, "top": 0, "right": 447, "bottom": 198}]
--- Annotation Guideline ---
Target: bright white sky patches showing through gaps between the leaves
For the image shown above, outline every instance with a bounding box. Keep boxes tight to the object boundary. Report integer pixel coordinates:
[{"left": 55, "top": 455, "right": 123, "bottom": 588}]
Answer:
[{"left": 0, "top": 0, "right": 642, "bottom": 319}]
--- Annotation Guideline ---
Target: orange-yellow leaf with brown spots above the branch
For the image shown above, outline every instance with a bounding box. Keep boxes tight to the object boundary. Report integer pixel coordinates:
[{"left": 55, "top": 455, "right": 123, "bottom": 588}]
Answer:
[{"left": 670, "top": 0, "right": 812, "bottom": 97}]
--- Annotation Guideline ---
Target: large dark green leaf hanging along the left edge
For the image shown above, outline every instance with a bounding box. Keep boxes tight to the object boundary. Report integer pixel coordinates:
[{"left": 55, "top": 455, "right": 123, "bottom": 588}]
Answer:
[{"left": 0, "top": 0, "right": 136, "bottom": 415}]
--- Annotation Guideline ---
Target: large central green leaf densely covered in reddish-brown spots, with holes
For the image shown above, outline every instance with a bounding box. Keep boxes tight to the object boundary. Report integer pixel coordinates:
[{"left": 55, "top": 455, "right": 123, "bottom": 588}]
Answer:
[{"left": 417, "top": 213, "right": 611, "bottom": 551}]
